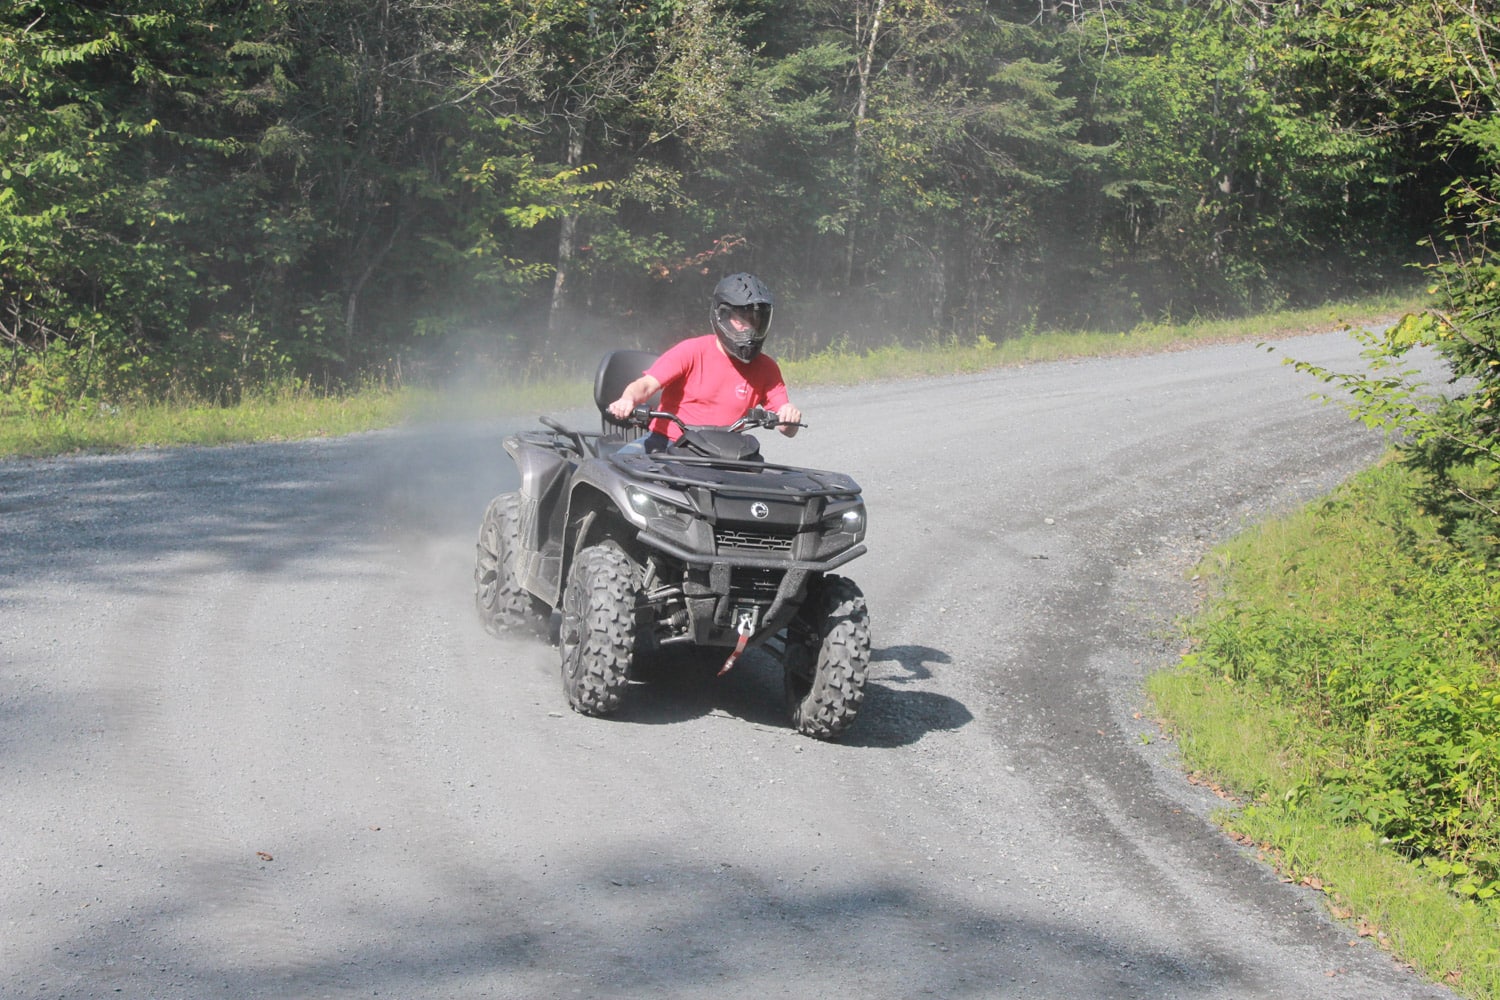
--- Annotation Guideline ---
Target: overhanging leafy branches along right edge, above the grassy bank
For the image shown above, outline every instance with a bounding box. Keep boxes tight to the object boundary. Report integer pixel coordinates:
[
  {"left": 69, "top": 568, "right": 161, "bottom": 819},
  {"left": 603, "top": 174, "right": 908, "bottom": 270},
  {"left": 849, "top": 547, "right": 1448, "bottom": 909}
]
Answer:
[{"left": 1272, "top": 3, "right": 1500, "bottom": 562}]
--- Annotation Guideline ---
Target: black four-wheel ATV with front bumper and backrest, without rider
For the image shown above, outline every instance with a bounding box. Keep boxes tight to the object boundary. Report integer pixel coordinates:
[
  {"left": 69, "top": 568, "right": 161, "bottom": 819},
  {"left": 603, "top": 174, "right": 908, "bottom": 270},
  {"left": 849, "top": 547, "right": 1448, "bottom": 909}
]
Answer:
[{"left": 474, "top": 351, "right": 870, "bottom": 739}]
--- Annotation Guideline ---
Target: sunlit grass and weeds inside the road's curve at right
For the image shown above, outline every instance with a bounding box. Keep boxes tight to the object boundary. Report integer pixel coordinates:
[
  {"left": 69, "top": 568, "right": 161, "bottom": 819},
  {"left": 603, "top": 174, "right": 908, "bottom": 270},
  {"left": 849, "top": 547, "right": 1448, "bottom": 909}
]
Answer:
[{"left": 1148, "top": 462, "right": 1500, "bottom": 999}]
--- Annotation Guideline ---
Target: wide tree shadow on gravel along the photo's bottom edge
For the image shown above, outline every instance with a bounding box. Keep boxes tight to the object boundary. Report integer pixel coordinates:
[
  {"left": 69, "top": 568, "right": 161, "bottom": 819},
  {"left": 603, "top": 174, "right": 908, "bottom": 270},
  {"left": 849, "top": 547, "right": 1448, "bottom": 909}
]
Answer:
[{"left": 9, "top": 829, "right": 1230, "bottom": 997}]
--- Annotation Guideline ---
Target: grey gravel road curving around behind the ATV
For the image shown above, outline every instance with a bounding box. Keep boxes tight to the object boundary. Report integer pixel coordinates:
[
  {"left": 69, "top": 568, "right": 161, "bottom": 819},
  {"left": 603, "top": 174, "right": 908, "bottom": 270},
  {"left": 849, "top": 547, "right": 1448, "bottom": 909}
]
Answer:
[{"left": 0, "top": 334, "right": 1452, "bottom": 1000}]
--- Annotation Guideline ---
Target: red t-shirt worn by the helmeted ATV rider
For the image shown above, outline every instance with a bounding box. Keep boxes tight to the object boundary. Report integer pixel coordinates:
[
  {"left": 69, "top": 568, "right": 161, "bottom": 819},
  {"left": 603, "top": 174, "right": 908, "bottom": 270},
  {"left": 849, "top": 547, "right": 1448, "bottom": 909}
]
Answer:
[{"left": 645, "top": 333, "right": 788, "bottom": 441}]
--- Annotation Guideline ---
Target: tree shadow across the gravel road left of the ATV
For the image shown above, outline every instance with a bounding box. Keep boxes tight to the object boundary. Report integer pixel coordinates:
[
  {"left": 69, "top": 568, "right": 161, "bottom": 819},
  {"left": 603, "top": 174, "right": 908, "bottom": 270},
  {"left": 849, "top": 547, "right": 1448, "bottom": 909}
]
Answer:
[{"left": 0, "top": 427, "right": 515, "bottom": 598}]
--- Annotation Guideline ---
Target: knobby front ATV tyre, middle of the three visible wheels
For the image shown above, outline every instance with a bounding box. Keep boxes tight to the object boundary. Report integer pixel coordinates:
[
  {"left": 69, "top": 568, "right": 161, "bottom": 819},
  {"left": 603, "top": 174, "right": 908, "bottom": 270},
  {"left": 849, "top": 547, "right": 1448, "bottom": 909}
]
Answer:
[{"left": 558, "top": 541, "right": 641, "bottom": 715}]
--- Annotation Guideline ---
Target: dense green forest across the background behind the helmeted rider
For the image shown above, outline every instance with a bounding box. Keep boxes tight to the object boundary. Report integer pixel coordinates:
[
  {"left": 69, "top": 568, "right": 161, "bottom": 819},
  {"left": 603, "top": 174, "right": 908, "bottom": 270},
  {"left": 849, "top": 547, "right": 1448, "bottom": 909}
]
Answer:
[{"left": 0, "top": 0, "right": 1493, "bottom": 411}]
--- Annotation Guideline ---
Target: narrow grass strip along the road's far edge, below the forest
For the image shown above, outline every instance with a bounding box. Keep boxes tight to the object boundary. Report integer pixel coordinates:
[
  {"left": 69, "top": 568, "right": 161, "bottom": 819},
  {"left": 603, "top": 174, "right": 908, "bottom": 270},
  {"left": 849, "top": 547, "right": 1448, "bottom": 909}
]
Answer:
[{"left": 0, "top": 294, "right": 1419, "bottom": 457}]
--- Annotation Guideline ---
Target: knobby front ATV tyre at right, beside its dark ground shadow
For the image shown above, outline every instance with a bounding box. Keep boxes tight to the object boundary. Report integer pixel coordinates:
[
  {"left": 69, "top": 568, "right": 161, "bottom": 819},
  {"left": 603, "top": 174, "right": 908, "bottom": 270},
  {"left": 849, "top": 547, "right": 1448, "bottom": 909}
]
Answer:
[{"left": 785, "top": 576, "right": 870, "bottom": 739}]
